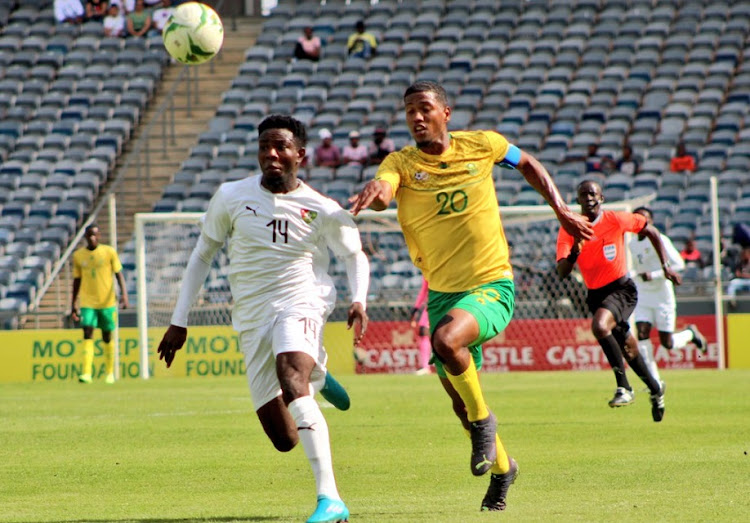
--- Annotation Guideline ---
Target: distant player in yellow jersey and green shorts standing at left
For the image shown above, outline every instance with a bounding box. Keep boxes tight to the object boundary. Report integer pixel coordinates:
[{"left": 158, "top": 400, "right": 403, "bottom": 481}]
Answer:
[{"left": 71, "top": 224, "right": 129, "bottom": 383}]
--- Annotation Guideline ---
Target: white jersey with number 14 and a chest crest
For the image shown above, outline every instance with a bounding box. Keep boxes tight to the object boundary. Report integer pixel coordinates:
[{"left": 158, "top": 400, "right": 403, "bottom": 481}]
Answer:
[{"left": 202, "top": 175, "right": 362, "bottom": 332}]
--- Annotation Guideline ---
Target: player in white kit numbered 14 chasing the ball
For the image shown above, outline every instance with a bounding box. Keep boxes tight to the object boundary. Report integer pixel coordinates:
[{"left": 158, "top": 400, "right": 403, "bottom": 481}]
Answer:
[{"left": 158, "top": 115, "right": 369, "bottom": 523}]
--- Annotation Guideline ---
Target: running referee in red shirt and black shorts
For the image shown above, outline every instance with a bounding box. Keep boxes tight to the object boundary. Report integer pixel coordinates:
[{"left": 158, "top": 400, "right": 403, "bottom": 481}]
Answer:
[{"left": 557, "top": 180, "right": 680, "bottom": 421}]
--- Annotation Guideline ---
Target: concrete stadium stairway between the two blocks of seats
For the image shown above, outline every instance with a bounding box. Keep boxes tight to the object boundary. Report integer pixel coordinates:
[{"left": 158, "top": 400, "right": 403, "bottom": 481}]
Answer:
[{"left": 22, "top": 17, "right": 263, "bottom": 329}]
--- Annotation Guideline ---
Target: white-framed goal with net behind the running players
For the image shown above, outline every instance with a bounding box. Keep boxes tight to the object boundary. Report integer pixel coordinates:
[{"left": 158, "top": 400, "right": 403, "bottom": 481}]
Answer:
[{"left": 135, "top": 192, "right": 650, "bottom": 377}]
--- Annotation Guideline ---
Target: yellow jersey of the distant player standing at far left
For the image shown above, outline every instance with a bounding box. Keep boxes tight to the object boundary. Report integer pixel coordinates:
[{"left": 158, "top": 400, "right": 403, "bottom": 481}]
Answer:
[{"left": 73, "top": 244, "right": 122, "bottom": 309}]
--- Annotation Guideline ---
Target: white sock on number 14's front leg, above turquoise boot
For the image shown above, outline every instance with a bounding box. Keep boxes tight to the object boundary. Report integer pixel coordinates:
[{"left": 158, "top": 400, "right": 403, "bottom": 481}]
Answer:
[{"left": 288, "top": 396, "right": 341, "bottom": 500}]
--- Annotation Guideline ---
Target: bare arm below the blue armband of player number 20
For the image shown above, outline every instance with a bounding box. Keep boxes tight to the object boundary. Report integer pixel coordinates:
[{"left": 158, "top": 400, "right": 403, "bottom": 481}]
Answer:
[{"left": 516, "top": 151, "right": 594, "bottom": 240}]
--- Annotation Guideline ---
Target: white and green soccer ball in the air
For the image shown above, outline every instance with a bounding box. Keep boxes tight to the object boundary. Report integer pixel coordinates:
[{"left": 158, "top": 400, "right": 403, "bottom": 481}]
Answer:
[{"left": 161, "top": 2, "right": 224, "bottom": 65}]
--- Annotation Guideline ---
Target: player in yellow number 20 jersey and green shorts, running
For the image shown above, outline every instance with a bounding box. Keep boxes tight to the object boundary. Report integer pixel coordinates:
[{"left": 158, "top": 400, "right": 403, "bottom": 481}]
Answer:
[{"left": 350, "top": 81, "right": 591, "bottom": 511}]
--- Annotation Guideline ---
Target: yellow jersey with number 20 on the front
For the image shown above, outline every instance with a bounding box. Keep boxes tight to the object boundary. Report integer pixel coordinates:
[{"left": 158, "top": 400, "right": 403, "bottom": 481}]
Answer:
[{"left": 375, "top": 131, "right": 513, "bottom": 292}]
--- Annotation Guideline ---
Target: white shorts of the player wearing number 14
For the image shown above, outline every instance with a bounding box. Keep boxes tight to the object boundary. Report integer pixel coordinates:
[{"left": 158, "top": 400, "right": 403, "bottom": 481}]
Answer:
[{"left": 240, "top": 310, "right": 328, "bottom": 411}]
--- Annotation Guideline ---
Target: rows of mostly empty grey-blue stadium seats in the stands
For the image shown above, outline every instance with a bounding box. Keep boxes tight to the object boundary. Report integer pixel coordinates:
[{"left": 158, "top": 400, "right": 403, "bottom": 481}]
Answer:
[{"left": 0, "top": 0, "right": 750, "bottom": 328}]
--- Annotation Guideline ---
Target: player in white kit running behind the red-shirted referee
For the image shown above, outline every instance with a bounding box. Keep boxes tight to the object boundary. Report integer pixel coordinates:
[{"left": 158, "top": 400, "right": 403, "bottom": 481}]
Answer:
[{"left": 630, "top": 207, "right": 707, "bottom": 381}]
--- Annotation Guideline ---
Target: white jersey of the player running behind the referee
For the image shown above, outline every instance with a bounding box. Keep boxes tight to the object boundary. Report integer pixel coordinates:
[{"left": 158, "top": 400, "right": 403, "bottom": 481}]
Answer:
[{"left": 630, "top": 234, "right": 685, "bottom": 305}]
